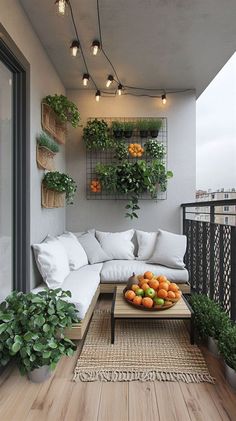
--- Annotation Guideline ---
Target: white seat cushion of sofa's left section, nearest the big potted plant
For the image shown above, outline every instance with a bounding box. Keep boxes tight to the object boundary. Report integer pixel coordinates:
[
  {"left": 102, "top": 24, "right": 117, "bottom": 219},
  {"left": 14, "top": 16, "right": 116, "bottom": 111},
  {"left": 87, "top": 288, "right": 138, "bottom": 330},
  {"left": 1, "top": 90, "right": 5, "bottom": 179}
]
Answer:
[{"left": 32, "top": 263, "right": 102, "bottom": 319}]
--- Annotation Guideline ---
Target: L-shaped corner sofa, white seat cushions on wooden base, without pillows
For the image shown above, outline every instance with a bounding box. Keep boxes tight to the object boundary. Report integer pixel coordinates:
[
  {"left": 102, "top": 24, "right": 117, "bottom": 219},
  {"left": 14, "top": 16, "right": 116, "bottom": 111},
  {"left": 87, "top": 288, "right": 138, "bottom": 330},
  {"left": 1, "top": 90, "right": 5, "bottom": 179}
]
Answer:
[{"left": 33, "top": 228, "right": 190, "bottom": 339}]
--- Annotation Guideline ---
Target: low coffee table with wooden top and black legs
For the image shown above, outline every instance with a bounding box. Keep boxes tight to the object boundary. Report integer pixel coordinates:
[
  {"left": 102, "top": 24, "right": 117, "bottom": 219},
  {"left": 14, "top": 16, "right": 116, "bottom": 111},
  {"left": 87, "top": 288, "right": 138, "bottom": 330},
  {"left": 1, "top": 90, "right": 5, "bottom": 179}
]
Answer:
[{"left": 111, "top": 286, "right": 194, "bottom": 345}]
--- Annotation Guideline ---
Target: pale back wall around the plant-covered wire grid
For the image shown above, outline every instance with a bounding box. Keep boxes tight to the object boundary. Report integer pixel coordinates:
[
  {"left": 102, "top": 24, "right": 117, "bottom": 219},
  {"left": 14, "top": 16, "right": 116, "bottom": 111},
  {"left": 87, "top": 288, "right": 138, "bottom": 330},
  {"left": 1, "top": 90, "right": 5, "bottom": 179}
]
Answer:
[{"left": 66, "top": 90, "right": 196, "bottom": 233}]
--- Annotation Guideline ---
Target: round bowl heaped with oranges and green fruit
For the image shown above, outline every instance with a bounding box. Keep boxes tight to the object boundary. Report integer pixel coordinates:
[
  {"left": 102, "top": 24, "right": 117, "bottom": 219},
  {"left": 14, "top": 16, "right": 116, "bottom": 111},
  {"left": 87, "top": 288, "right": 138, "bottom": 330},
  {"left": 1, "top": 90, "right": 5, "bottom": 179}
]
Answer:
[{"left": 123, "top": 271, "right": 181, "bottom": 311}]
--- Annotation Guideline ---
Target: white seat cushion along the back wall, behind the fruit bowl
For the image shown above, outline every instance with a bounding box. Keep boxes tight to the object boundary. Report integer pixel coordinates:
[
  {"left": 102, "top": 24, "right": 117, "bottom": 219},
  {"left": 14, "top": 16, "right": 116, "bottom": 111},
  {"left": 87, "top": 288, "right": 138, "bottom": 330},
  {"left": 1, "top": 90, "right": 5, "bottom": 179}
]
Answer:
[{"left": 101, "top": 260, "right": 188, "bottom": 283}]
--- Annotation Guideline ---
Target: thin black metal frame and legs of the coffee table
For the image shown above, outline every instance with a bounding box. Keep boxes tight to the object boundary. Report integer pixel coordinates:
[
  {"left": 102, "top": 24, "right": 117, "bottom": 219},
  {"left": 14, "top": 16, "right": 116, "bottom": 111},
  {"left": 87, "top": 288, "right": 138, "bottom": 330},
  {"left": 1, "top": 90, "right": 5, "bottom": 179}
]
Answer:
[{"left": 111, "top": 287, "right": 195, "bottom": 345}]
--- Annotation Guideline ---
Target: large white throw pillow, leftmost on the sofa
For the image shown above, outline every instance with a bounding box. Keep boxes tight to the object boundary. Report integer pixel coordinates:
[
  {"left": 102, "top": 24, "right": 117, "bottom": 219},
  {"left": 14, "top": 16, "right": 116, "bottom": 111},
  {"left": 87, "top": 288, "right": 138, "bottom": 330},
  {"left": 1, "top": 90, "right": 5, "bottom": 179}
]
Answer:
[{"left": 32, "top": 237, "right": 70, "bottom": 288}]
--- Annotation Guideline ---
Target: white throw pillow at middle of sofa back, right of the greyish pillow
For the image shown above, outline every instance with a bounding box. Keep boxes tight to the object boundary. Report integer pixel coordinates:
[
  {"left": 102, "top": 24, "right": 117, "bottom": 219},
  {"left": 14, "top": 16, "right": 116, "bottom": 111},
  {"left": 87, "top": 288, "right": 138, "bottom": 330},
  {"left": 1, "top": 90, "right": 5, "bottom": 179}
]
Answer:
[{"left": 96, "top": 230, "right": 135, "bottom": 260}]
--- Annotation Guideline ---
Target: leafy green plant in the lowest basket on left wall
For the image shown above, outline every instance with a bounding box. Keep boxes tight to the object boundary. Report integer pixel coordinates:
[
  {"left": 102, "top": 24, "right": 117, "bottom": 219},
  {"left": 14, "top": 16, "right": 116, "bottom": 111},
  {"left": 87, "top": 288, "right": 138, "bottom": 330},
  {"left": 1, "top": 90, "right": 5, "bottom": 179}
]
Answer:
[{"left": 43, "top": 171, "right": 77, "bottom": 205}]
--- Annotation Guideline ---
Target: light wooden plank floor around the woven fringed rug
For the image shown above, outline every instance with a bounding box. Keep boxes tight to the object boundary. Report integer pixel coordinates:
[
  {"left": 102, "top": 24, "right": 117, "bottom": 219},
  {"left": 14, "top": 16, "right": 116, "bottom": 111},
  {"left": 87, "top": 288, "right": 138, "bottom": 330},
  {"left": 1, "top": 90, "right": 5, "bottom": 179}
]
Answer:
[{"left": 0, "top": 298, "right": 236, "bottom": 421}]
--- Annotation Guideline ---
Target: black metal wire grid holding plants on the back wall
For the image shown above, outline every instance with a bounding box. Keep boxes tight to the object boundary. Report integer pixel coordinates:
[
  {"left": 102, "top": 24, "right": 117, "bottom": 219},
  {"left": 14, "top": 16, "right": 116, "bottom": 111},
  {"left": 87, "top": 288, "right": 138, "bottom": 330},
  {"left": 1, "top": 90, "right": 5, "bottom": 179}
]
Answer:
[{"left": 86, "top": 117, "right": 168, "bottom": 201}]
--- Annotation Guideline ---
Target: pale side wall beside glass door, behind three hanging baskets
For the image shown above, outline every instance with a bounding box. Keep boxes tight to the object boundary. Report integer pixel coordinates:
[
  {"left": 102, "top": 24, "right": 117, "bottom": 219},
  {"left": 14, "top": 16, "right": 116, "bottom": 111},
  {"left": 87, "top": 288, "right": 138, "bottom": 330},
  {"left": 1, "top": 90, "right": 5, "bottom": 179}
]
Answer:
[{"left": 0, "top": 0, "right": 65, "bottom": 285}]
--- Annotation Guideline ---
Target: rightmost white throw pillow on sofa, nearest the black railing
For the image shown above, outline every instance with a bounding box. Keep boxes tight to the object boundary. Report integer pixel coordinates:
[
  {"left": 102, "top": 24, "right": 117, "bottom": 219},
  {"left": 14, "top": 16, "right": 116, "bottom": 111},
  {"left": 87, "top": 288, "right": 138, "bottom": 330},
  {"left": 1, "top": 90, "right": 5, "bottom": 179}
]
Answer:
[{"left": 149, "top": 230, "right": 187, "bottom": 269}]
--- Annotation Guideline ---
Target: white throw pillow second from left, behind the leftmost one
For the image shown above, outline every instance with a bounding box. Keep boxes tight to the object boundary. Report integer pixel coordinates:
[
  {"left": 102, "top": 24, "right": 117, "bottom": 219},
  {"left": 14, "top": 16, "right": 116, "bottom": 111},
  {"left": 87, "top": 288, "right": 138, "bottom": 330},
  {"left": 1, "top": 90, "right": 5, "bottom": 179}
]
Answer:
[{"left": 57, "top": 232, "right": 88, "bottom": 270}]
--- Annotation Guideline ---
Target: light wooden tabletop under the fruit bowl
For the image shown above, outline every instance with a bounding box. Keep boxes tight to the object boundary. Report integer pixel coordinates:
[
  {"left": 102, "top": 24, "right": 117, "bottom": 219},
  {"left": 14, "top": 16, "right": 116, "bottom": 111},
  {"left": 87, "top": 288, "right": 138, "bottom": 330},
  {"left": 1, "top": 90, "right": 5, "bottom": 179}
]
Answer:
[{"left": 114, "top": 286, "right": 191, "bottom": 319}]
